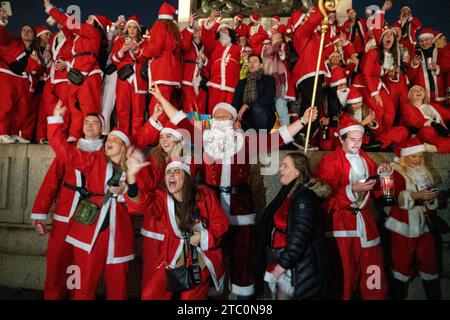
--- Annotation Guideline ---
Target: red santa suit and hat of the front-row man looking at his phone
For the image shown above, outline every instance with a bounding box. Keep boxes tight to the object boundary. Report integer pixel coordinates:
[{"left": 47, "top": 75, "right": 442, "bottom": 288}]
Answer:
[{"left": 316, "top": 121, "right": 387, "bottom": 300}]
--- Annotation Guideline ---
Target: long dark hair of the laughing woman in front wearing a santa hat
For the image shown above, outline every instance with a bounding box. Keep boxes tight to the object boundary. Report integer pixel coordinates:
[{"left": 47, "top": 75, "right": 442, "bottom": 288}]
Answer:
[{"left": 176, "top": 172, "right": 197, "bottom": 233}]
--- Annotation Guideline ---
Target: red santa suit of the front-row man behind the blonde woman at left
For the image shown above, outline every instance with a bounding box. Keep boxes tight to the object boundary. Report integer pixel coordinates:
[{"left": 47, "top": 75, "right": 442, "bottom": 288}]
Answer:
[{"left": 31, "top": 139, "right": 103, "bottom": 300}]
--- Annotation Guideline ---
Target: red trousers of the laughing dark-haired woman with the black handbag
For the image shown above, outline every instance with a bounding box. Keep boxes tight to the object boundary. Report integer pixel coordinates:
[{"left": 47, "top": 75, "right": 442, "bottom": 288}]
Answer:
[{"left": 141, "top": 266, "right": 211, "bottom": 300}]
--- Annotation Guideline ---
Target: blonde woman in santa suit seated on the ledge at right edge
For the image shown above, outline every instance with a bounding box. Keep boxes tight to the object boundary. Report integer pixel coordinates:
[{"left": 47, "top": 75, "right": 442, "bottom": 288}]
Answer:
[{"left": 401, "top": 85, "right": 450, "bottom": 153}]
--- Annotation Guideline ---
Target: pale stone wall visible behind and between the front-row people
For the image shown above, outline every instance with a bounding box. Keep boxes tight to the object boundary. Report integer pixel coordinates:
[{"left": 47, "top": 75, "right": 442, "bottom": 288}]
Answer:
[{"left": 0, "top": 145, "right": 450, "bottom": 299}]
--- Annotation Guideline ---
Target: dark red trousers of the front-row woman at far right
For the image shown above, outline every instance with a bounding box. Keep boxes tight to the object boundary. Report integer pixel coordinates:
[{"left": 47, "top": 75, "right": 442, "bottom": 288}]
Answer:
[{"left": 390, "top": 232, "right": 438, "bottom": 282}]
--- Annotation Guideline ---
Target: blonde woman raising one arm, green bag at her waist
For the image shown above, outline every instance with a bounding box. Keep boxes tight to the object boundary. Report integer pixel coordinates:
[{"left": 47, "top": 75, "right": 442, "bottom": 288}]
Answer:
[{"left": 48, "top": 101, "right": 134, "bottom": 300}]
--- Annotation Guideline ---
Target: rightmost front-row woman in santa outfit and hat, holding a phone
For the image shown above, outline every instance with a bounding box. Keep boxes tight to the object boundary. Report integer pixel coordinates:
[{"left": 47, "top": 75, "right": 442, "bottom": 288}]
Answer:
[{"left": 385, "top": 138, "right": 441, "bottom": 300}]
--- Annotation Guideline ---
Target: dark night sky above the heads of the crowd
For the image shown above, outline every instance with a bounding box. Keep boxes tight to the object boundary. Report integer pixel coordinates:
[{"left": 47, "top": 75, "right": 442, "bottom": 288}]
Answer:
[{"left": 3, "top": 0, "right": 450, "bottom": 35}]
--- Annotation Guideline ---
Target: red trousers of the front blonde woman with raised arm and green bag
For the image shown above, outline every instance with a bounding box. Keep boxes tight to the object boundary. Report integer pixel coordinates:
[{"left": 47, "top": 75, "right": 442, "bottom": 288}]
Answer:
[{"left": 72, "top": 228, "right": 129, "bottom": 300}]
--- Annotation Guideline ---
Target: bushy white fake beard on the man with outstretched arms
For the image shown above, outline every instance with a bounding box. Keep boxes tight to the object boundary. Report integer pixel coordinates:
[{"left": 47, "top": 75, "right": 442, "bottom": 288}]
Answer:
[{"left": 203, "top": 119, "right": 244, "bottom": 160}]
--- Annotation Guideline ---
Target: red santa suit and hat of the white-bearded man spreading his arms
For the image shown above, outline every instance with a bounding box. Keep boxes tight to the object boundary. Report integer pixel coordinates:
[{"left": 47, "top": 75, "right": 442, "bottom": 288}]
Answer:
[{"left": 171, "top": 104, "right": 293, "bottom": 296}]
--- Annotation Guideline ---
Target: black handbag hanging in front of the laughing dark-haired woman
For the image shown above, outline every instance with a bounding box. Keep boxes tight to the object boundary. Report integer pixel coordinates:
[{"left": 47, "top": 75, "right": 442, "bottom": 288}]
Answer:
[{"left": 165, "top": 238, "right": 194, "bottom": 292}]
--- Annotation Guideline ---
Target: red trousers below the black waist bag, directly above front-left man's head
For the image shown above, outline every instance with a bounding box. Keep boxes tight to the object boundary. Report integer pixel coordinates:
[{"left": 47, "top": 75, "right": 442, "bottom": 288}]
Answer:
[{"left": 68, "top": 74, "right": 103, "bottom": 138}]
